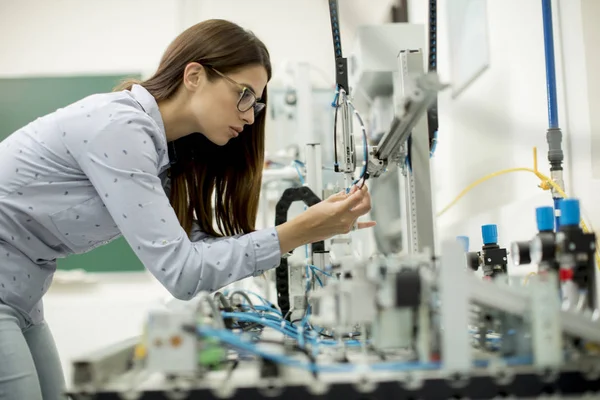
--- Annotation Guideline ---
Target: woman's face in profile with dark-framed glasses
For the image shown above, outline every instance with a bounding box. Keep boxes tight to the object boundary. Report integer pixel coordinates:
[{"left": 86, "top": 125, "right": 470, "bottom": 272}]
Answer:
[{"left": 189, "top": 65, "right": 268, "bottom": 146}]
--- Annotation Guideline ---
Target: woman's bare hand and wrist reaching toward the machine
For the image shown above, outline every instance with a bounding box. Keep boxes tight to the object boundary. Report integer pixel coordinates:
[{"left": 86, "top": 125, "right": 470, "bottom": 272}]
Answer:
[{"left": 277, "top": 184, "right": 375, "bottom": 253}]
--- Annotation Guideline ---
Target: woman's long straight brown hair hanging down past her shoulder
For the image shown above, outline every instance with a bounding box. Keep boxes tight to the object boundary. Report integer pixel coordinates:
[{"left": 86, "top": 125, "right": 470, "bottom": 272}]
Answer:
[{"left": 115, "top": 19, "right": 271, "bottom": 236}]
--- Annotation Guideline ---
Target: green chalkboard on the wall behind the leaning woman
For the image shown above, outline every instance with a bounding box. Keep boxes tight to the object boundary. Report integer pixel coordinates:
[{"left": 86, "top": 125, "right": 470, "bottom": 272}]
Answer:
[{"left": 0, "top": 74, "right": 144, "bottom": 272}]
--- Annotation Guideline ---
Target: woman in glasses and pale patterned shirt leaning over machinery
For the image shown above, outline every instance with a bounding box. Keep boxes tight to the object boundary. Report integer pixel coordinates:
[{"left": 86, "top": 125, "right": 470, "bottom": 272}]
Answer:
[{"left": 0, "top": 20, "right": 373, "bottom": 400}]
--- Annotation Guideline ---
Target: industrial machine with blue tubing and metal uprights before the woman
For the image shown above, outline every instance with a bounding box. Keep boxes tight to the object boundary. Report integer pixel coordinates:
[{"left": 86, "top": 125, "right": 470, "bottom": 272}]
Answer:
[{"left": 65, "top": 0, "right": 600, "bottom": 400}]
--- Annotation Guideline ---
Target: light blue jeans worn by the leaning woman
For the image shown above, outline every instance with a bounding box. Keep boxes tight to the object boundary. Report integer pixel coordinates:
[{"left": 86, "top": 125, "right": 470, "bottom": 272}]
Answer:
[{"left": 0, "top": 303, "right": 67, "bottom": 400}]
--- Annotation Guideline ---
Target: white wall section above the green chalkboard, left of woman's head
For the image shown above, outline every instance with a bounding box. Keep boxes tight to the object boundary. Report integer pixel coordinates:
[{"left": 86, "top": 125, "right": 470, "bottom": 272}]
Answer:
[{"left": 0, "top": 0, "right": 180, "bottom": 76}]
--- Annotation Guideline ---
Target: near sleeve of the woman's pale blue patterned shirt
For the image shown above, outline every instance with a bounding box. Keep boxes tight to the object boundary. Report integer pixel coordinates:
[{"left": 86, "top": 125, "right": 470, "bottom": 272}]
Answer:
[{"left": 78, "top": 114, "right": 281, "bottom": 300}]
